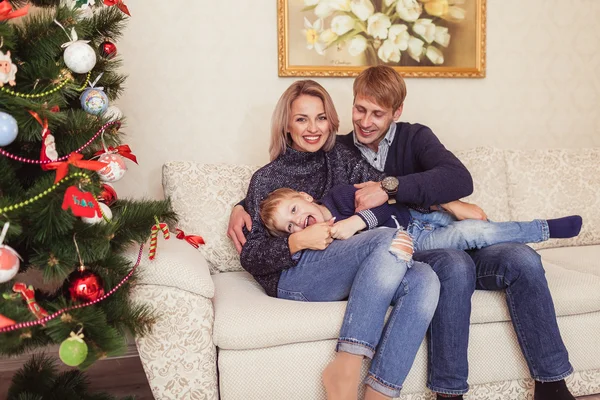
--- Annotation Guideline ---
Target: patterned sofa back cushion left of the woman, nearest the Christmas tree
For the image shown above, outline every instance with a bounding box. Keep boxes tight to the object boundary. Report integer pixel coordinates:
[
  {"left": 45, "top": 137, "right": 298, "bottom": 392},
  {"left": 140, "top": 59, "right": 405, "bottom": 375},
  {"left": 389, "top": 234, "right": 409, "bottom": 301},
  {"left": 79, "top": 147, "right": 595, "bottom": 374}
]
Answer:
[{"left": 163, "top": 161, "right": 258, "bottom": 273}]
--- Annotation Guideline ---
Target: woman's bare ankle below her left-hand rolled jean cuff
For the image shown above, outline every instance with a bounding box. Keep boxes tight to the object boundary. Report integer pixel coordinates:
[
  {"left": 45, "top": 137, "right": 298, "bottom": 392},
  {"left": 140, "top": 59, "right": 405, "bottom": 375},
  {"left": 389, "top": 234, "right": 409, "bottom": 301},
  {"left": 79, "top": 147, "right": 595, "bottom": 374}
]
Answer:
[{"left": 323, "top": 351, "right": 363, "bottom": 400}]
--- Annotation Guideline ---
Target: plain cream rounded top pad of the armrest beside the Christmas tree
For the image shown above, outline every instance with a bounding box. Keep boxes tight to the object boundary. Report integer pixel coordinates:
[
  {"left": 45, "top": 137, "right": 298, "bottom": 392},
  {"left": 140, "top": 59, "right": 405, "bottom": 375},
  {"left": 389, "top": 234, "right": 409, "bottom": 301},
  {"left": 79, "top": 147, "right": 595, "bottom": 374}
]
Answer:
[{"left": 125, "top": 236, "right": 215, "bottom": 299}]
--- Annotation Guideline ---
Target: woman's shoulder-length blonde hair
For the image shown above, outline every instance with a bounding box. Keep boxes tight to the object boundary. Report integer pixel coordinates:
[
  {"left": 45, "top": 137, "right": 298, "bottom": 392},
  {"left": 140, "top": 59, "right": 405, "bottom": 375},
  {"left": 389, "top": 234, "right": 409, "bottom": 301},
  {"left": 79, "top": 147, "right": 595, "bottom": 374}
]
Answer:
[{"left": 269, "top": 79, "right": 340, "bottom": 161}]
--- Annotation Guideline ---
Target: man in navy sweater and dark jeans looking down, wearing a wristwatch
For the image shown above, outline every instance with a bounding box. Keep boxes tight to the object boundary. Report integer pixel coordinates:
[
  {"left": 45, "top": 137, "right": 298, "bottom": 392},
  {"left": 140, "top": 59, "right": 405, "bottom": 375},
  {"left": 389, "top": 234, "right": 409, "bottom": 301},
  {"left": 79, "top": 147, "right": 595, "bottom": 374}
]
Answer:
[{"left": 228, "top": 66, "right": 574, "bottom": 400}]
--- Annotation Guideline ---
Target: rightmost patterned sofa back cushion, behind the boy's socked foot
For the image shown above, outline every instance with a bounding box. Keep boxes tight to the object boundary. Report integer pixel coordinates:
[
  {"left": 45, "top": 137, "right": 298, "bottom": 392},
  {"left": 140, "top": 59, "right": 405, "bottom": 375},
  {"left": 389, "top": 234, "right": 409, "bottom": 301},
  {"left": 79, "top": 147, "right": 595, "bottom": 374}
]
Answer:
[{"left": 505, "top": 148, "right": 600, "bottom": 249}]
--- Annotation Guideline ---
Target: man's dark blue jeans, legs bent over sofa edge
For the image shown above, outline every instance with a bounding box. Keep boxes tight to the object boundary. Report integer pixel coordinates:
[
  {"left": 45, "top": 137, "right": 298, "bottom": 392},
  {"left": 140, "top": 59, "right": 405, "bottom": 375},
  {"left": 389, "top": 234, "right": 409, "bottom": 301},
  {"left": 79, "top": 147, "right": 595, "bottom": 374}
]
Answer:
[{"left": 413, "top": 243, "right": 573, "bottom": 394}]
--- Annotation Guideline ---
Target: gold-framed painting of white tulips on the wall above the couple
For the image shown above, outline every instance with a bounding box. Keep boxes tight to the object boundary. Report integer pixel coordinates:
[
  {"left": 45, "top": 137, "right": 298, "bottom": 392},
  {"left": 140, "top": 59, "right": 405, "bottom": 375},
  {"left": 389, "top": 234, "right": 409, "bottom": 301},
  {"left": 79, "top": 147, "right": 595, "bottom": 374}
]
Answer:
[{"left": 277, "top": 0, "right": 486, "bottom": 78}]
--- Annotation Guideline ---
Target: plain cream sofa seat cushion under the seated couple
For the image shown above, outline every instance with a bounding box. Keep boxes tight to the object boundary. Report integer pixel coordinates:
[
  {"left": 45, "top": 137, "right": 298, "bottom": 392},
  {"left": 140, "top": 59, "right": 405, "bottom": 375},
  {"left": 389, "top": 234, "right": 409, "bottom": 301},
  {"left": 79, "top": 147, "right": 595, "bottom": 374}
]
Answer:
[{"left": 213, "top": 260, "right": 600, "bottom": 350}]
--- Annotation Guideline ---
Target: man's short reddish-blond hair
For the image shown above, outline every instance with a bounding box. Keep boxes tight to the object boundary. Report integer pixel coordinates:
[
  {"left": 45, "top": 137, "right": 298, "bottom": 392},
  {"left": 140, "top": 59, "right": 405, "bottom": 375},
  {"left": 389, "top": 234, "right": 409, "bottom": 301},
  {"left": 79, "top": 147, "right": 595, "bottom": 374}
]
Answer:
[{"left": 353, "top": 65, "right": 406, "bottom": 111}]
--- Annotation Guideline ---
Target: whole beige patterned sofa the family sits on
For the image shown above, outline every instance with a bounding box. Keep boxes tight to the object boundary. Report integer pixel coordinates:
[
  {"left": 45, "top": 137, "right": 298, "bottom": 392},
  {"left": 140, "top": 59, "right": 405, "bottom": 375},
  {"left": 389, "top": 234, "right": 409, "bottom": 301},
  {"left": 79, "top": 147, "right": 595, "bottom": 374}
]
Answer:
[{"left": 136, "top": 148, "right": 600, "bottom": 400}]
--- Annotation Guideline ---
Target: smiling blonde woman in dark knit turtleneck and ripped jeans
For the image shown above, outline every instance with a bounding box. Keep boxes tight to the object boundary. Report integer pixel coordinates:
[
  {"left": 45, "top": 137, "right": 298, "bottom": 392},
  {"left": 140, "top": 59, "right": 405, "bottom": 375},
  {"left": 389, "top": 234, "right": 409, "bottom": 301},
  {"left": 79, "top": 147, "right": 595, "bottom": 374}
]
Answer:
[{"left": 241, "top": 80, "right": 439, "bottom": 400}]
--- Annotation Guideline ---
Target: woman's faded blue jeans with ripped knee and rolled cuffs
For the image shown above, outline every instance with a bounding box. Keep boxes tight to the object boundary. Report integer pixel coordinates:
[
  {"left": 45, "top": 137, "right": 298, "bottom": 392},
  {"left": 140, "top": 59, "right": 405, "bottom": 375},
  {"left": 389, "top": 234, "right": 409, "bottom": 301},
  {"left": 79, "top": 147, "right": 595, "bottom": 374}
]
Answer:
[{"left": 278, "top": 228, "right": 439, "bottom": 397}]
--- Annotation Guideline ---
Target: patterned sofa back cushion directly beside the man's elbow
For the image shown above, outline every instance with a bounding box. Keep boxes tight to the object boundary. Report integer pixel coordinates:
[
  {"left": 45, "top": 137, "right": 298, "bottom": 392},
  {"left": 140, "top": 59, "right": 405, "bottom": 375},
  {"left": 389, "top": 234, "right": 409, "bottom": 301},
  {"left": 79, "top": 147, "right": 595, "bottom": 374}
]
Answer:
[{"left": 455, "top": 147, "right": 510, "bottom": 221}]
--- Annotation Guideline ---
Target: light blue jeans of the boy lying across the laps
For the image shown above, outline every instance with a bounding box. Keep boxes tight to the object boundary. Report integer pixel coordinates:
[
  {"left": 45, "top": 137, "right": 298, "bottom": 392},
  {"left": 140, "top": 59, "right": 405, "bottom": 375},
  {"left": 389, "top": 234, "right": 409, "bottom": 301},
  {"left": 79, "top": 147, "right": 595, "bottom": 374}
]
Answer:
[{"left": 407, "top": 210, "right": 550, "bottom": 251}]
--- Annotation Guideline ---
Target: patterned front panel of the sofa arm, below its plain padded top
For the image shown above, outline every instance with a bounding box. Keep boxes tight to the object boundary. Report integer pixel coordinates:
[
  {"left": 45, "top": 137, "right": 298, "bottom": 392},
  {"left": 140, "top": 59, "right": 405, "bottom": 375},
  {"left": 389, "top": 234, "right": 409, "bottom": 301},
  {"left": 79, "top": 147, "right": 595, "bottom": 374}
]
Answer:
[{"left": 132, "top": 284, "right": 219, "bottom": 400}]
